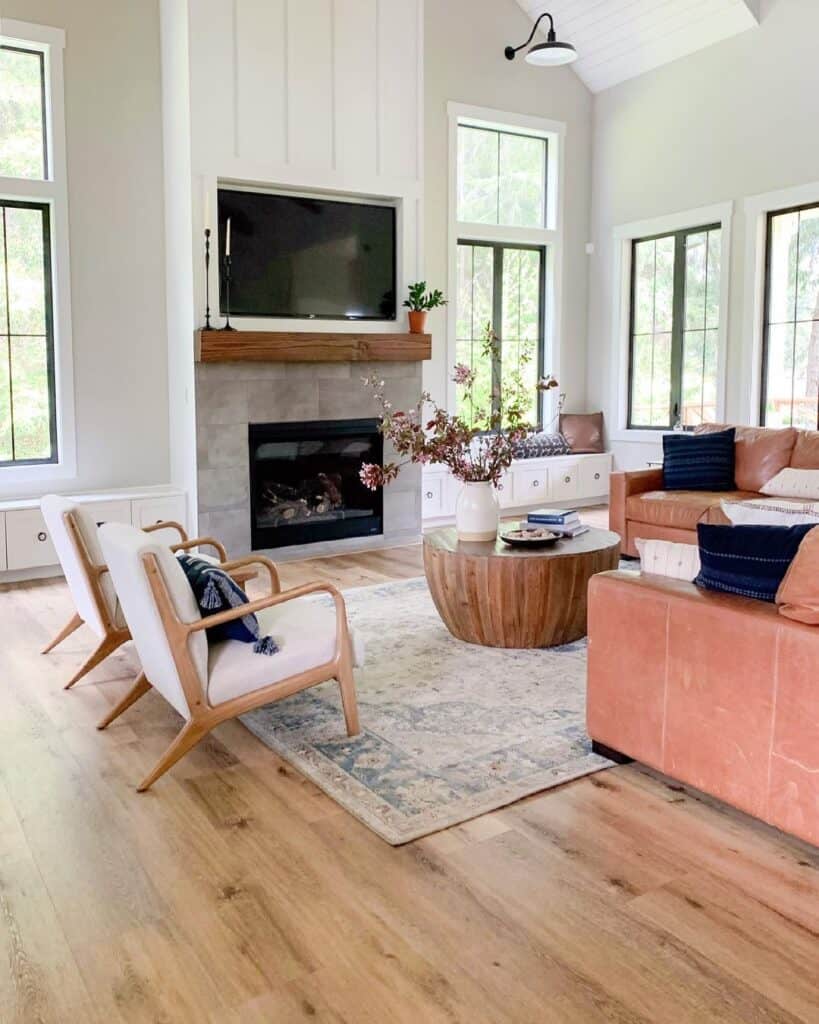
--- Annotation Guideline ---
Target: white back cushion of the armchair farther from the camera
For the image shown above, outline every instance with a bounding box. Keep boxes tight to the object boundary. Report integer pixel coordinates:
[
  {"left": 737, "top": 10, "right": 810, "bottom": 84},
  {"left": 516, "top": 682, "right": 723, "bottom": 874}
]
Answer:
[{"left": 40, "top": 495, "right": 117, "bottom": 637}]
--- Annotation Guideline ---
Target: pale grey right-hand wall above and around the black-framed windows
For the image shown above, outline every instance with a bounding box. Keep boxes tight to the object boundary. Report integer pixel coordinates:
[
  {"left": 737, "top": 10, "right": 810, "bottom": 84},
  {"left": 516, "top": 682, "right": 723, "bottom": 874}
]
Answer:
[{"left": 588, "top": 0, "right": 819, "bottom": 468}]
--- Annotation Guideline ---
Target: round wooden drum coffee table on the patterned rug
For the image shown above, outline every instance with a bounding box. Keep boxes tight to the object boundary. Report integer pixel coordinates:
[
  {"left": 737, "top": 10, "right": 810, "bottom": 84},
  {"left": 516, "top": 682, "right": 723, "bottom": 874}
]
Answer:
[{"left": 424, "top": 526, "right": 620, "bottom": 647}]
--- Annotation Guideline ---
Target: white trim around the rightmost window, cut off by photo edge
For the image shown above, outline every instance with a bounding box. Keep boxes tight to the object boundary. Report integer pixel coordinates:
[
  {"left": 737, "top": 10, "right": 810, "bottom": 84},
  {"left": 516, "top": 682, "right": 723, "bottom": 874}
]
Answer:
[{"left": 740, "top": 181, "right": 819, "bottom": 426}]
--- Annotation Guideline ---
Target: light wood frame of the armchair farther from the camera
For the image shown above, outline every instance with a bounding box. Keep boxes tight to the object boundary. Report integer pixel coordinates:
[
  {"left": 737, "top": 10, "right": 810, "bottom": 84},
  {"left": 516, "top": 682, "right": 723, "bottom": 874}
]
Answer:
[{"left": 41, "top": 510, "right": 230, "bottom": 690}]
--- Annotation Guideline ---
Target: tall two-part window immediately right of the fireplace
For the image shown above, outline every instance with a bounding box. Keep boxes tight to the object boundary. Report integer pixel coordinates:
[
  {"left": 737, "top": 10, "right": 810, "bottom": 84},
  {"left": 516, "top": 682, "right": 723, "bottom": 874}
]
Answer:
[{"left": 455, "top": 124, "right": 549, "bottom": 425}]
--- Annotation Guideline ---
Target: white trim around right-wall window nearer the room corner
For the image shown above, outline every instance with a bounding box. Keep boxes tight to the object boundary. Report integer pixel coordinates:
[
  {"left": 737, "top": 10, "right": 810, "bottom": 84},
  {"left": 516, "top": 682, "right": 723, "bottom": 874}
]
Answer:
[{"left": 609, "top": 202, "right": 734, "bottom": 444}]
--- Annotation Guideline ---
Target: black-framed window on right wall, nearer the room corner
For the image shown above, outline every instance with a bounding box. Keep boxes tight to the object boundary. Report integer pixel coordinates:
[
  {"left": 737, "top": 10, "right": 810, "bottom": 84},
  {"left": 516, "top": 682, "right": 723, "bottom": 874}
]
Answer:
[{"left": 629, "top": 224, "right": 722, "bottom": 430}]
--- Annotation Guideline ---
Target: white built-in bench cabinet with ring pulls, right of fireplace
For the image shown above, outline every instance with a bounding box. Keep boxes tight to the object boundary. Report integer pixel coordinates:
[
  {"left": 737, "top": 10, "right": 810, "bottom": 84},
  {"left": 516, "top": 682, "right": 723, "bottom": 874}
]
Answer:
[{"left": 423, "top": 453, "right": 611, "bottom": 523}]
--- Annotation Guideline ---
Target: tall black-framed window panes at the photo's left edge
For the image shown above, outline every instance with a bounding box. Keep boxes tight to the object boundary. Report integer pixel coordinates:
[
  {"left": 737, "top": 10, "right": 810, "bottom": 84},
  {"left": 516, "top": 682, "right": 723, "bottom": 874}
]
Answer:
[{"left": 0, "top": 44, "right": 57, "bottom": 466}]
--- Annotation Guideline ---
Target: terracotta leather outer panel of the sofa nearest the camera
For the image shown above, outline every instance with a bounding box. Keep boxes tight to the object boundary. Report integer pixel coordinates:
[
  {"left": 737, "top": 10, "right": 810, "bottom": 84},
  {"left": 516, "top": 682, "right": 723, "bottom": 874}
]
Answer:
[{"left": 587, "top": 577, "right": 819, "bottom": 844}]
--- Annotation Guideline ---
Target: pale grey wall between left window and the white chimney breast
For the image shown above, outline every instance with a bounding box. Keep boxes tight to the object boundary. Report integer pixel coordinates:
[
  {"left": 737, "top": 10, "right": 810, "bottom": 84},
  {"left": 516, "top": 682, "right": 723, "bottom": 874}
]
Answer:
[{"left": 0, "top": 0, "right": 168, "bottom": 497}]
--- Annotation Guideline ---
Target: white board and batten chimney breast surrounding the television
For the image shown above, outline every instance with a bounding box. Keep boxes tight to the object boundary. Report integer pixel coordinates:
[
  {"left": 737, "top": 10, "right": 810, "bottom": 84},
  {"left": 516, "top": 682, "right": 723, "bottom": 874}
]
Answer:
[{"left": 162, "top": 0, "right": 424, "bottom": 520}]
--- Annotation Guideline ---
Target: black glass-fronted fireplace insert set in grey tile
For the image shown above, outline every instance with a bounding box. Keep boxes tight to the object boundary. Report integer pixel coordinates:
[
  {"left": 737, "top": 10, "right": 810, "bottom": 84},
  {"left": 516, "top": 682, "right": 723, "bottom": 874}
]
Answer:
[{"left": 248, "top": 419, "right": 384, "bottom": 550}]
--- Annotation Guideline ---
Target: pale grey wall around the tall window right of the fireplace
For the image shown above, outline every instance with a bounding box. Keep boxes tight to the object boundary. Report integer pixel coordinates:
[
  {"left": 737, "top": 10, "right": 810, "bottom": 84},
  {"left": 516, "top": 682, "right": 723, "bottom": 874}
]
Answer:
[{"left": 424, "top": 0, "right": 592, "bottom": 410}]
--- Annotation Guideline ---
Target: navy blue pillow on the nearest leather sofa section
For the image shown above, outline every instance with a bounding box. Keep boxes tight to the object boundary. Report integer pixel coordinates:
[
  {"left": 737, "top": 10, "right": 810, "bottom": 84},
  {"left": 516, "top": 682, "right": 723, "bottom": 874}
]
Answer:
[{"left": 694, "top": 523, "right": 817, "bottom": 601}]
